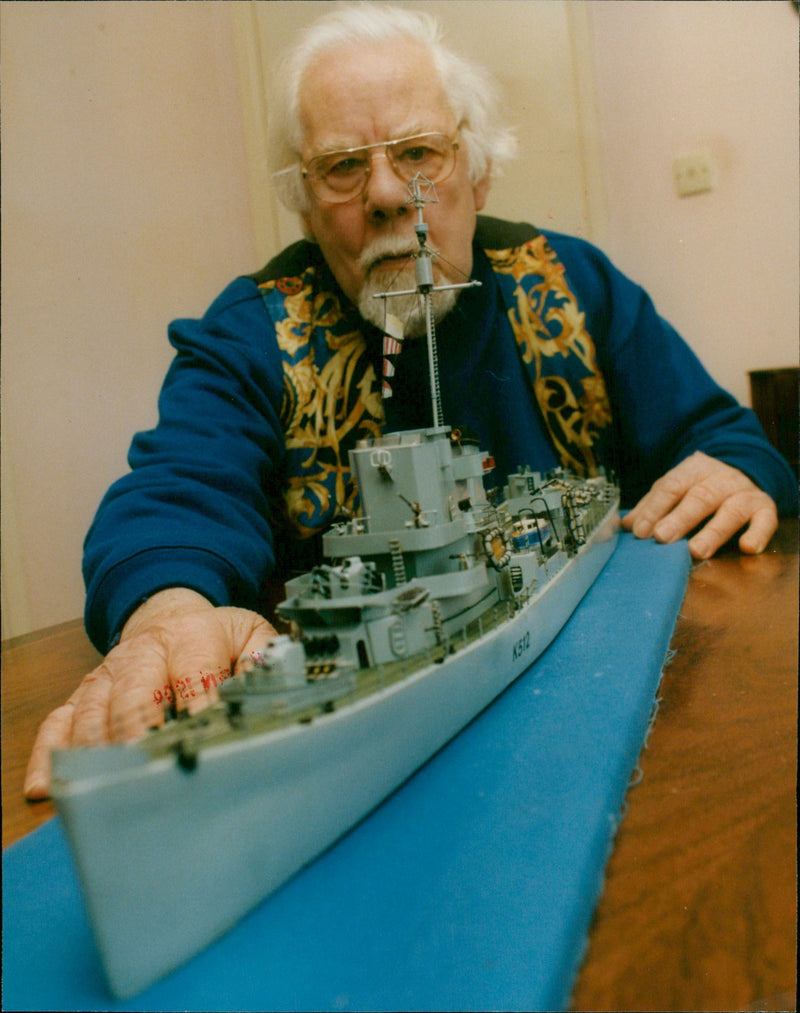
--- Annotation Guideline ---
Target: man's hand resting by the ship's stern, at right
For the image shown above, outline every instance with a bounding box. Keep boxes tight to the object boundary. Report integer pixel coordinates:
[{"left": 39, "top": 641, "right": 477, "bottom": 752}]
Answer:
[{"left": 622, "top": 451, "right": 778, "bottom": 559}]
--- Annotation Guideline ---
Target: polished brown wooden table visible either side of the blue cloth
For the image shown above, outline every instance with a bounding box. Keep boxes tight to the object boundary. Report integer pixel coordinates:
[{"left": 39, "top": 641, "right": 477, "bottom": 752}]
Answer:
[{"left": 2, "top": 521, "right": 798, "bottom": 1010}]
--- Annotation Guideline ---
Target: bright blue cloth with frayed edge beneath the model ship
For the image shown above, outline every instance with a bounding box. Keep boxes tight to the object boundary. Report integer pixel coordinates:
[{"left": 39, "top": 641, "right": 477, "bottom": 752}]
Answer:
[{"left": 3, "top": 535, "right": 689, "bottom": 1010}]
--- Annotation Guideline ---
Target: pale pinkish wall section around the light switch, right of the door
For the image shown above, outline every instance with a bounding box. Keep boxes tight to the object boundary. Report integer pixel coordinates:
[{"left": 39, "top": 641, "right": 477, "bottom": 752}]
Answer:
[{"left": 590, "top": 0, "right": 800, "bottom": 403}]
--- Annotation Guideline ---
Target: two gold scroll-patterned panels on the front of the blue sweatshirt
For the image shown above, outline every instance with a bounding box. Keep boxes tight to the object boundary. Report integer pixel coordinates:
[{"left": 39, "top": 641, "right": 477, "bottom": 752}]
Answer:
[{"left": 261, "top": 236, "right": 611, "bottom": 538}]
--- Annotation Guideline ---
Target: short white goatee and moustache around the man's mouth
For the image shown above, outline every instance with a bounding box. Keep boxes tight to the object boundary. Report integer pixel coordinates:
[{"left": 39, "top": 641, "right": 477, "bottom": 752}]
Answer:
[{"left": 358, "top": 237, "right": 459, "bottom": 337}]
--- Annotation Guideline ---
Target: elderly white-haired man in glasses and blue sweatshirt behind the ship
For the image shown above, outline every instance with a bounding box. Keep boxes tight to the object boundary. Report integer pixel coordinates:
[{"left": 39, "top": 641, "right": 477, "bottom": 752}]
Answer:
[{"left": 25, "top": 4, "right": 796, "bottom": 798}]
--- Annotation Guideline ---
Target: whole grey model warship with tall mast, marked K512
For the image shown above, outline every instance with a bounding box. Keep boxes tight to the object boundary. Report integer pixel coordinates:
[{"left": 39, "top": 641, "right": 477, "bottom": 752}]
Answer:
[{"left": 53, "top": 179, "right": 619, "bottom": 997}]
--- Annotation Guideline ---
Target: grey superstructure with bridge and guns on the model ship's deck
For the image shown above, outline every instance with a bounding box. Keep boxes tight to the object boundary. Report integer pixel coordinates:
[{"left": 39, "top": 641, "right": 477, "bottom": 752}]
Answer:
[{"left": 241, "top": 427, "right": 616, "bottom": 713}]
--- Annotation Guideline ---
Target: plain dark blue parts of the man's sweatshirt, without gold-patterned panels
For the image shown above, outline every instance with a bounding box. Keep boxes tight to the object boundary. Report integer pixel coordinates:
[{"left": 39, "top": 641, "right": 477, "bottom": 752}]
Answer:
[{"left": 84, "top": 219, "right": 797, "bottom": 651}]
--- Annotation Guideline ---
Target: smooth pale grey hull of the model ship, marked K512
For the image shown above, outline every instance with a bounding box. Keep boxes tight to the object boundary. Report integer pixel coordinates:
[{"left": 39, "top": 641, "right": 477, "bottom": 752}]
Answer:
[{"left": 54, "top": 511, "right": 618, "bottom": 997}]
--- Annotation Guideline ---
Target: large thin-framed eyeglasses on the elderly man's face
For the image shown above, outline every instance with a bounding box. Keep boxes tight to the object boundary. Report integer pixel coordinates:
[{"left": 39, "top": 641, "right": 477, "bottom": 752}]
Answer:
[{"left": 303, "top": 134, "right": 459, "bottom": 204}]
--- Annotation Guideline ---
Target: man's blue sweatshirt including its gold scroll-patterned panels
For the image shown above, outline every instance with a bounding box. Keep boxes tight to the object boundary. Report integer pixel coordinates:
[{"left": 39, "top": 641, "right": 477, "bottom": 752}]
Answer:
[{"left": 84, "top": 218, "right": 797, "bottom": 651}]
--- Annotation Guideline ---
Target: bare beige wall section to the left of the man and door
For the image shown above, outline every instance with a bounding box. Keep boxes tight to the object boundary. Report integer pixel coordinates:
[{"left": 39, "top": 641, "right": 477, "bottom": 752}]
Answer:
[{"left": 0, "top": 2, "right": 257, "bottom": 636}]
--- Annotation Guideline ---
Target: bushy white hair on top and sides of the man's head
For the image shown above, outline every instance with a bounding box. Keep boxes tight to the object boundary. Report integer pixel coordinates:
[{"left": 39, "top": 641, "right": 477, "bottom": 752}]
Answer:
[{"left": 269, "top": 0, "right": 516, "bottom": 212}]
